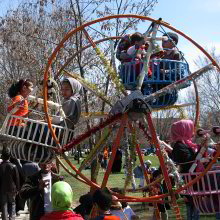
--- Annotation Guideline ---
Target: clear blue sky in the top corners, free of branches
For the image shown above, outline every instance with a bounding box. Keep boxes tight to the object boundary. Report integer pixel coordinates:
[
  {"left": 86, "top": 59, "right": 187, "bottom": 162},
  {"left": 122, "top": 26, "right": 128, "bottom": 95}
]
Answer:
[{"left": 0, "top": 0, "right": 220, "bottom": 71}]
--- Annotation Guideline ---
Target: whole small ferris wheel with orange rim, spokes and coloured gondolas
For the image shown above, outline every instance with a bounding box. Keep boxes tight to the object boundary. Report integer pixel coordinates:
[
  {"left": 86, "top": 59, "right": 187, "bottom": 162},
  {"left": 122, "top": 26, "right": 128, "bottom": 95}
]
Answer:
[{"left": 1, "top": 15, "right": 220, "bottom": 219}]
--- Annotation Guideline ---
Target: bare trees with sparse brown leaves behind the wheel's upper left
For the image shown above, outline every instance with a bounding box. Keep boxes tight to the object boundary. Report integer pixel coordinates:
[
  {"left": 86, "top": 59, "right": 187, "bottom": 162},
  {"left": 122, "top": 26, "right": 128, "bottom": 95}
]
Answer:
[{"left": 0, "top": 0, "right": 157, "bottom": 186}]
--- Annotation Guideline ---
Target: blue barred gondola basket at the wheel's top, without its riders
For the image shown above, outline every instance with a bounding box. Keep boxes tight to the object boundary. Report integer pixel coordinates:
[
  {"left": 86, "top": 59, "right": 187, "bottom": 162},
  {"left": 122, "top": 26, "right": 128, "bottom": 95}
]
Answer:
[{"left": 120, "top": 59, "right": 190, "bottom": 108}]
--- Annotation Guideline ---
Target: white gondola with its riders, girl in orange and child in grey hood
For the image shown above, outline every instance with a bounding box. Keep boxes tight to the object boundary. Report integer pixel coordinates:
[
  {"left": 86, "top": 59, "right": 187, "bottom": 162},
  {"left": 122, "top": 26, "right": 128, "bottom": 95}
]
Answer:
[{"left": 0, "top": 78, "right": 82, "bottom": 162}]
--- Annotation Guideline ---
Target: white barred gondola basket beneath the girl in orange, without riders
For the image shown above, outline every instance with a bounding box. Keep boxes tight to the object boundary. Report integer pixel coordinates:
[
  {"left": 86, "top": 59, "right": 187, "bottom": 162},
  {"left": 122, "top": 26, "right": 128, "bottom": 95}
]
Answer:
[{"left": 0, "top": 97, "right": 74, "bottom": 162}]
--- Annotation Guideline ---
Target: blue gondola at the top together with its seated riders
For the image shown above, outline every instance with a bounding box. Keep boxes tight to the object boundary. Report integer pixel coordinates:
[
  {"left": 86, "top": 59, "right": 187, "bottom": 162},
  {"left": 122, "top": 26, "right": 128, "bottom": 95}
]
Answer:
[{"left": 116, "top": 29, "right": 189, "bottom": 108}]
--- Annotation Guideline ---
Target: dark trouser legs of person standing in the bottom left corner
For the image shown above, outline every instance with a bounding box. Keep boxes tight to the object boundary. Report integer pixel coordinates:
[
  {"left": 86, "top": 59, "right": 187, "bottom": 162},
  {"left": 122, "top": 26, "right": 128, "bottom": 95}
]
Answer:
[{"left": 1, "top": 193, "right": 16, "bottom": 220}]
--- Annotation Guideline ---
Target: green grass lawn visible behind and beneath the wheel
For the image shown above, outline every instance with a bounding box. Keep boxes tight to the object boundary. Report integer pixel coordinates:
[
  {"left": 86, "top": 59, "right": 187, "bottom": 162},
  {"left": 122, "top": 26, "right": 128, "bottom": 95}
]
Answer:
[{"left": 61, "top": 156, "right": 215, "bottom": 220}]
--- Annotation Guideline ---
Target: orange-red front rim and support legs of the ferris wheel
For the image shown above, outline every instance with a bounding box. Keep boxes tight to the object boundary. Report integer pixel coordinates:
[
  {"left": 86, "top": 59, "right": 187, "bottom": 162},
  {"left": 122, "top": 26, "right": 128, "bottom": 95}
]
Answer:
[{"left": 41, "top": 14, "right": 220, "bottom": 219}]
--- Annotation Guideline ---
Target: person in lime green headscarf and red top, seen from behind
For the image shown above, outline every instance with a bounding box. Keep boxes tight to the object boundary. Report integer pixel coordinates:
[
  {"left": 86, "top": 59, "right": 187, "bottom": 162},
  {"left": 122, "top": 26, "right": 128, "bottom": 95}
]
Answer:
[{"left": 40, "top": 181, "right": 83, "bottom": 220}]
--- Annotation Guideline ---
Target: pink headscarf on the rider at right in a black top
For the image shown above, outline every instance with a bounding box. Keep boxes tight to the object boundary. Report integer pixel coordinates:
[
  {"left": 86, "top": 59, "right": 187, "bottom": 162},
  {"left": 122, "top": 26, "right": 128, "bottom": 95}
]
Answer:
[{"left": 171, "top": 120, "right": 198, "bottom": 152}]
